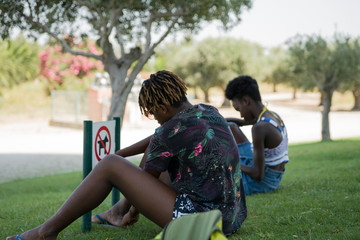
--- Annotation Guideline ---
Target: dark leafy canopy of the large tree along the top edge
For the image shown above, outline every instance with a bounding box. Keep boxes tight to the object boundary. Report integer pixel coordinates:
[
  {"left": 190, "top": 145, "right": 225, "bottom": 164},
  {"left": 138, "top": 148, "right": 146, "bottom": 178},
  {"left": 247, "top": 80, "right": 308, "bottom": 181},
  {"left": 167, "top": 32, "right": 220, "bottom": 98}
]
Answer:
[{"left": 0, "top": 0, "right": 251, "bottom": 42}]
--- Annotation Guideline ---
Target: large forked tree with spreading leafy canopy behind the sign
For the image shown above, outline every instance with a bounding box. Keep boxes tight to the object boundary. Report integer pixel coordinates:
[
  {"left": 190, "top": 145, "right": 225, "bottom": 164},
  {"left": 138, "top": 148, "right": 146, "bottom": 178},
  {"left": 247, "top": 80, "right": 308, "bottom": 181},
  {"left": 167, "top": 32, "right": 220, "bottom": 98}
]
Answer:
[{"left": 0, "top": 0, "right": 251, "bottom": 119}]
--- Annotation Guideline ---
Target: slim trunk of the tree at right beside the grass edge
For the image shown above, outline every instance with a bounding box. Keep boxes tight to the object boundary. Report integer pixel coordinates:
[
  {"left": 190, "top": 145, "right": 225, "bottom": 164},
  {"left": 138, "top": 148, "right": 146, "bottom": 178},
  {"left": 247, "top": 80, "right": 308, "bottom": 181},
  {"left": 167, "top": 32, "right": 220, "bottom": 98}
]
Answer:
[{"left": 321, "top": 89, "right": 334, "bottom": 141}]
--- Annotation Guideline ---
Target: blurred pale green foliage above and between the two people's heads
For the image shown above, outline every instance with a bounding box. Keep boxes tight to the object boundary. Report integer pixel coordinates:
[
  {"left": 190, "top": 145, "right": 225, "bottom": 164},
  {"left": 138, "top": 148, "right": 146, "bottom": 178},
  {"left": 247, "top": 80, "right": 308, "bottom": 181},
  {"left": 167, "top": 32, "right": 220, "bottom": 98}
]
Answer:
[{"left": 153, "top": 37, "right": 272, "bottom": 82}]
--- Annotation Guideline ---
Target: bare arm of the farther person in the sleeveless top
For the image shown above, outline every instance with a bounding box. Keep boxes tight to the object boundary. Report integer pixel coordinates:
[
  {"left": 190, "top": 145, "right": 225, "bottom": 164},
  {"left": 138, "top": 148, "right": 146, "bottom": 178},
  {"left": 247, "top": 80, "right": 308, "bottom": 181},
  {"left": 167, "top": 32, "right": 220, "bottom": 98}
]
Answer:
[{"left": 240, "top": 124, "right": 265, "bottom": 181}]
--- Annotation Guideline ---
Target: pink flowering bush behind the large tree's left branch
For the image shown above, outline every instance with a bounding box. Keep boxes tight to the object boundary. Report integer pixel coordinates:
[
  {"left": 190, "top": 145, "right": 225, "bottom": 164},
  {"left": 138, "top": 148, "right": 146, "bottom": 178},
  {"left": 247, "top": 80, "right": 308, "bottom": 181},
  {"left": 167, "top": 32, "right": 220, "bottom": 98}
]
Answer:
[{"left": 39, "top": 37, "right": 103, "bottom": 90}]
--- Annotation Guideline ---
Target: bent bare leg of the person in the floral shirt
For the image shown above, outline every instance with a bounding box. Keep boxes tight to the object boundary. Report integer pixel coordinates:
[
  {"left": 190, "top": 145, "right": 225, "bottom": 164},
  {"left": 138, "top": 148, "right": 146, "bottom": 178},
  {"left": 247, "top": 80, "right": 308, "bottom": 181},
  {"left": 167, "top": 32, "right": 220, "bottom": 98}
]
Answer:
[{"left": 8, "top": 155, "right": 177, "bottom": 240}]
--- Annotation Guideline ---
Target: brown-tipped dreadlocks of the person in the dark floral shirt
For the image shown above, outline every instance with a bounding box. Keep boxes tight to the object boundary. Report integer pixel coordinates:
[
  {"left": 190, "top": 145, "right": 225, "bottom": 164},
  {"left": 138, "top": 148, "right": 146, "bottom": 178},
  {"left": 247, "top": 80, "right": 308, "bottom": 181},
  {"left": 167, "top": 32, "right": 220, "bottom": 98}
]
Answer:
[{"left": 139, "top": 70, "right": 187, "bottom": 116}]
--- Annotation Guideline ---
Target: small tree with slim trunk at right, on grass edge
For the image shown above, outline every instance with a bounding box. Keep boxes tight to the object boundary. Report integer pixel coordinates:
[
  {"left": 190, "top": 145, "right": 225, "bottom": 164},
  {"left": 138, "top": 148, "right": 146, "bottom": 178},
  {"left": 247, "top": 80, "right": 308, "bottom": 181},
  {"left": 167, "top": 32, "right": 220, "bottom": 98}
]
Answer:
[{"left": 287, "top": 35, "right": 351, "bottom": 141}]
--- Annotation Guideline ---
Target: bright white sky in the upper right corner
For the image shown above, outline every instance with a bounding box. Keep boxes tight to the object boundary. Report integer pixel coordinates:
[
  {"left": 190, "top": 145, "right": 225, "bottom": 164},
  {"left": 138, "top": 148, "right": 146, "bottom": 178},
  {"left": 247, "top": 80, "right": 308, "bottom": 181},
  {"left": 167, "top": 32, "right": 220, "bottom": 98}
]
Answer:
[{"left": 195, "top": 0, "right": 360, "bottom": 48}]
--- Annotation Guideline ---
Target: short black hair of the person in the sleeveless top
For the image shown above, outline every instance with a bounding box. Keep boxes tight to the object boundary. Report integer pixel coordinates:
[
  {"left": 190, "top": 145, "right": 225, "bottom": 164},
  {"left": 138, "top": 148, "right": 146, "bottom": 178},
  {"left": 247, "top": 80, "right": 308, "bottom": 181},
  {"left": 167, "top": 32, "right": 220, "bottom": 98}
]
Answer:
[{"left": 225, "top": 75, "right": 261, "bottom": 102}]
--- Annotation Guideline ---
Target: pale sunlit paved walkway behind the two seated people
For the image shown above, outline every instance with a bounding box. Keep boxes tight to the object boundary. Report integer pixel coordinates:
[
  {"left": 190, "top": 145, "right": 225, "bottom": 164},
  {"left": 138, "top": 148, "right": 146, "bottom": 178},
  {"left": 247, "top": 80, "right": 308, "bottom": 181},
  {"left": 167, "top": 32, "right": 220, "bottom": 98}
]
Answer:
[{"left": 0, "top": 94, "right": 360, "bottom": 183}]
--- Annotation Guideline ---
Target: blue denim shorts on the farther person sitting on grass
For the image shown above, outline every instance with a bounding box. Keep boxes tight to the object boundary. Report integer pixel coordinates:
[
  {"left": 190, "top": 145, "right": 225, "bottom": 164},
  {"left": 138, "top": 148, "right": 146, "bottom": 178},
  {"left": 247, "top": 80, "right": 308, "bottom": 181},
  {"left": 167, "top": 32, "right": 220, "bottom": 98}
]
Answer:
[{"left": 238, "top": 142, "right": 285, "bottom": 195}]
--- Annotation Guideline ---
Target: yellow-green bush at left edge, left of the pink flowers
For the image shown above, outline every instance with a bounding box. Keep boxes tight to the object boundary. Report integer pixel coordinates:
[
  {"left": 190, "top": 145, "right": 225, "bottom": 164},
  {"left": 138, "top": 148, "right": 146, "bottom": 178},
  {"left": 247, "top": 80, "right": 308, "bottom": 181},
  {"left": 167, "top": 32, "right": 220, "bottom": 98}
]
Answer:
[{"left": 0, "top": 36, "right": 39, "bottom": 88}]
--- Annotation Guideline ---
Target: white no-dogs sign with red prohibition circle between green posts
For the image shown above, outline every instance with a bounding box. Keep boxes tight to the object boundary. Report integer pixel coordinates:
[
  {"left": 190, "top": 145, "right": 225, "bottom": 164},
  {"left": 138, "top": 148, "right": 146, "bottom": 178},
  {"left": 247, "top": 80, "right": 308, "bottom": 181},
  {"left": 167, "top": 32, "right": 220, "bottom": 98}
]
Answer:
[{"left": 92, "top": 120, "right": 115, "bottom": 168}]
